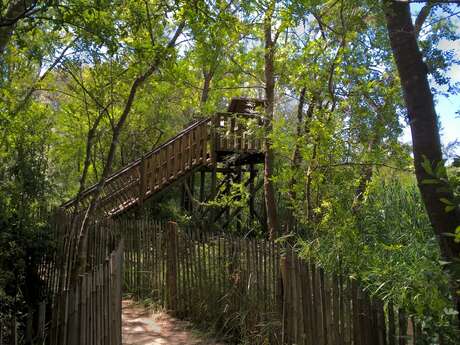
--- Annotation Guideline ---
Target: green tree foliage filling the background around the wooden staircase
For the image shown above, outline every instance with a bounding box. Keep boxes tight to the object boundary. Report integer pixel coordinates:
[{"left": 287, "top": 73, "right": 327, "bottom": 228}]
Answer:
[{"left": 0, "top": 0, "right": 460, "bottom": 342}]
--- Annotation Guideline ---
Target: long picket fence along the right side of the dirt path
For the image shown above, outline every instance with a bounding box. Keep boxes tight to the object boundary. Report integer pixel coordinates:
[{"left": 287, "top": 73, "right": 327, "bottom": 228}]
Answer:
[{"left": 121, "top": 220, "right": 432, "bottom": 345}]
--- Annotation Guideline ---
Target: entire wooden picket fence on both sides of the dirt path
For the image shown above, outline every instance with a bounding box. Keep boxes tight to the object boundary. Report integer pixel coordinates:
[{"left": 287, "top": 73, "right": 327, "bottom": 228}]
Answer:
[{"left": 15, "top": 215, "right": 434, "bottom": 345}]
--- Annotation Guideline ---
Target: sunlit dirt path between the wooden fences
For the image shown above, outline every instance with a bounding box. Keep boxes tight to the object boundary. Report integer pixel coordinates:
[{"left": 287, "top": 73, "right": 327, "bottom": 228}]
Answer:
[{"left": 123, "top": 300, "right": 223, "bottom": 345}]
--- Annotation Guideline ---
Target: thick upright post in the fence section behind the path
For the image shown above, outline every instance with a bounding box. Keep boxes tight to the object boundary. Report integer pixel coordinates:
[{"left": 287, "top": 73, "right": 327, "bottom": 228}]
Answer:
[{"left": 166, "top": 222, "right": 177, "bottom": 312}]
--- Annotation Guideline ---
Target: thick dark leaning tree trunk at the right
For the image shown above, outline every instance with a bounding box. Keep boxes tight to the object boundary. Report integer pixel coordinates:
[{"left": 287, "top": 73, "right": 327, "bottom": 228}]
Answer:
[{"left": 383, "top": 0, "right": 460, "bottom": 310}]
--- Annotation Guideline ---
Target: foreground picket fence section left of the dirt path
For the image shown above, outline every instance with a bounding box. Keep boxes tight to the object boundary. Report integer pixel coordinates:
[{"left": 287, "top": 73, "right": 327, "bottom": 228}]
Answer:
[{"left": 49, "top": 242, "right": 123, "bottom": 345}]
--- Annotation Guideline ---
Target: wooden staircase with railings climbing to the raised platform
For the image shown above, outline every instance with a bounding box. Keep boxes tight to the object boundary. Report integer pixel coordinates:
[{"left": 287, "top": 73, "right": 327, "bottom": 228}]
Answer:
[{"left": 62, "top": 101, "right": 263, "bottom": 217}]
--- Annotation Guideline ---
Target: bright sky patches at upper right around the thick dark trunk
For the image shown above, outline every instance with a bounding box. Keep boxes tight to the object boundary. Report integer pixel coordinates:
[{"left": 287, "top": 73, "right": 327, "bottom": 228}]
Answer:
[{"left": 401, "top": 5, "right": 460, "bottom": 155}]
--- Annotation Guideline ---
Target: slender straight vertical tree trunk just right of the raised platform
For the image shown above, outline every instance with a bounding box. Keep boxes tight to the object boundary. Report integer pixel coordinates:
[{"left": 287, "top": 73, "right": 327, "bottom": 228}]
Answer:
[{"left": 264, "top": 1, "right": 278, "bottom": 239}]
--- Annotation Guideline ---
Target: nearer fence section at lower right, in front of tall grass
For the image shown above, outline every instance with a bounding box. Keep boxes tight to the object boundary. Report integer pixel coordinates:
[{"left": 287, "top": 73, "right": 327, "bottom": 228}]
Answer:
[{"left": 281, "top": 250, "right": 422, "bottom": 345}]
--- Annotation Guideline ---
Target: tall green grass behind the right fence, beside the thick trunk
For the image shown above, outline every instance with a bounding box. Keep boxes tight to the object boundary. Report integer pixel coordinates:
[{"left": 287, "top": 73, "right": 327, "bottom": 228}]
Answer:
[{"left": 300, "top": 173, "right": 459, "bottom": 344}]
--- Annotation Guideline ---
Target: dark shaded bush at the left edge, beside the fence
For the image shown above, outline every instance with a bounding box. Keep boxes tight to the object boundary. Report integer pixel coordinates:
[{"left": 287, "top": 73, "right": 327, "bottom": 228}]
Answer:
[{"left": 0, "top": 106, "right": 51, "bottom": 342}]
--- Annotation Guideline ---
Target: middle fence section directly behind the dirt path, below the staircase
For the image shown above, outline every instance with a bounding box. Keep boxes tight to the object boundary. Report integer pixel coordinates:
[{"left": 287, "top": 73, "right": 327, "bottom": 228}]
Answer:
[{"left": 122, "top": 220, "right": 279, "bottom": 337}]
